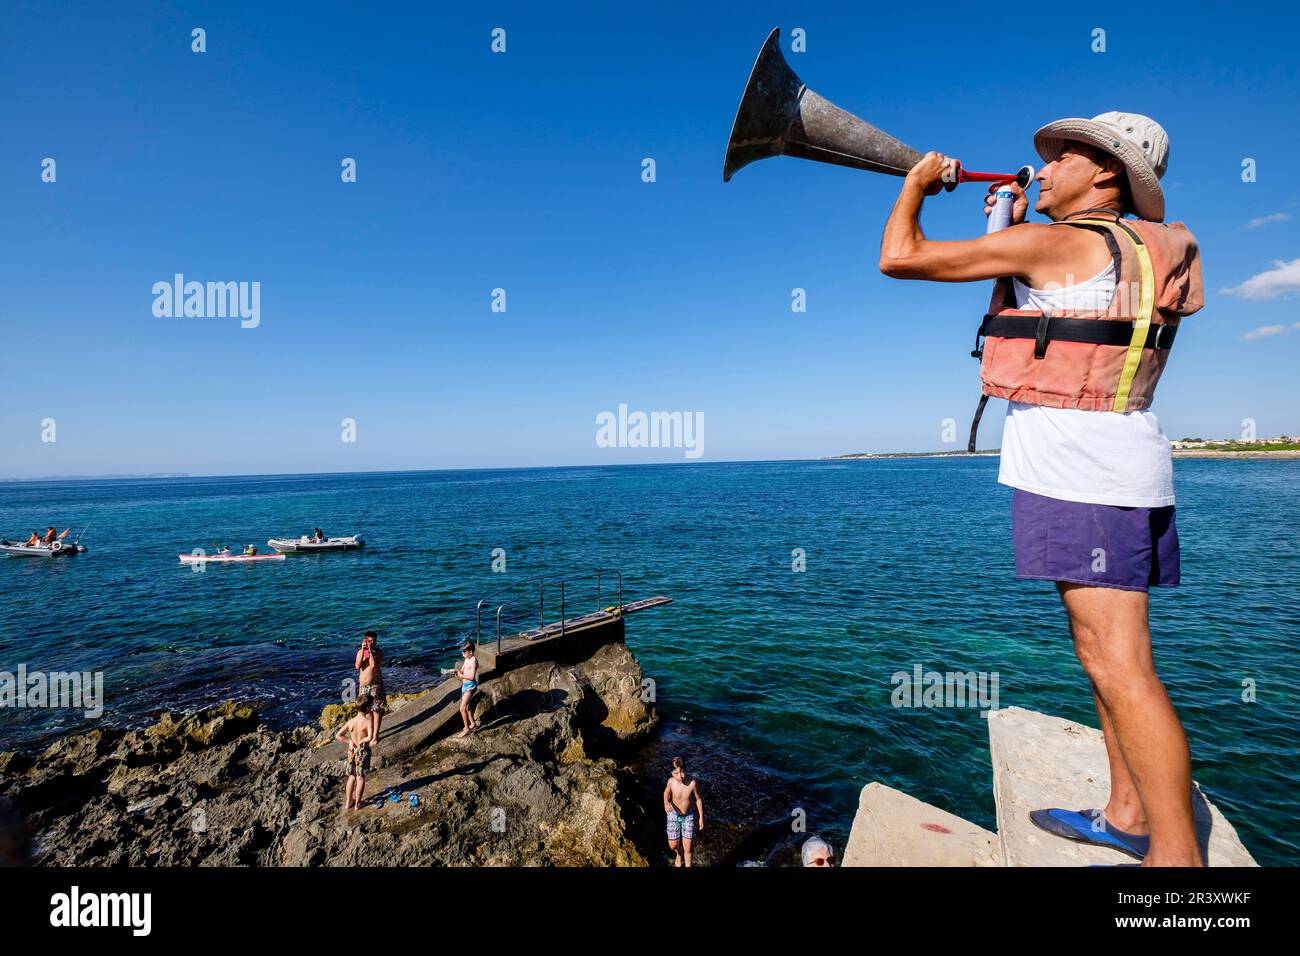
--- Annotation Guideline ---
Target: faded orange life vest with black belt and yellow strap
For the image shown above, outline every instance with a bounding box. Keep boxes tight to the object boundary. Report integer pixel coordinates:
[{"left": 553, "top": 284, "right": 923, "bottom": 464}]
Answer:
[{"left": 969, "top": 209, "right": 1205, "bottom": 451}]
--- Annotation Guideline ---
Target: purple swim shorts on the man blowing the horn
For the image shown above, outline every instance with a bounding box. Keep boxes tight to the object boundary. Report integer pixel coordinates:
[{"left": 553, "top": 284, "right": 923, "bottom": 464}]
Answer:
[{"left": 1011, "top": 488, "right": 1179, "bottom": 591}]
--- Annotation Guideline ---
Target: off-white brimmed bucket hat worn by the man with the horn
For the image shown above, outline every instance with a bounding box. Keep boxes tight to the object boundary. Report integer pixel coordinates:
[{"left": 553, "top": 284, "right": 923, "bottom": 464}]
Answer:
[{"left": 1034, "top": 111, "right": 1169, "bottom": 222}]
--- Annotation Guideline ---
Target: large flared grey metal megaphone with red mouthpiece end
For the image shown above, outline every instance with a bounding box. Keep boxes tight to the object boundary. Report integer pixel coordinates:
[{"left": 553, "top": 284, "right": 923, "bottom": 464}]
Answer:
[{"left": 723, "top": 27, "right": 1034, "bottom": 189}]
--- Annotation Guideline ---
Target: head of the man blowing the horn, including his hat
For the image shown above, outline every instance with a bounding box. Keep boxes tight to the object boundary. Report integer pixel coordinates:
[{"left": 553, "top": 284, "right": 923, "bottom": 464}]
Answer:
[{"left": 1034, "top": 112, "right": 1169, "bottom": 222}]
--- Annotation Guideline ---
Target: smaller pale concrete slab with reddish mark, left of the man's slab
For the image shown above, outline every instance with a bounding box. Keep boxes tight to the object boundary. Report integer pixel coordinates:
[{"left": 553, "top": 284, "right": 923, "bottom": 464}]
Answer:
[{"left": 842, "top": 783, "right": 1002, "bottom": 866}]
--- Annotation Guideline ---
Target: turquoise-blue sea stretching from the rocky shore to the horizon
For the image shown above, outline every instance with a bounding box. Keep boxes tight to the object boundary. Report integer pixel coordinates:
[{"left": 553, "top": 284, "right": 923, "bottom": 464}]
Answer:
[{"left": 0, "top": 458, "right": 1300, "bottom": 865}]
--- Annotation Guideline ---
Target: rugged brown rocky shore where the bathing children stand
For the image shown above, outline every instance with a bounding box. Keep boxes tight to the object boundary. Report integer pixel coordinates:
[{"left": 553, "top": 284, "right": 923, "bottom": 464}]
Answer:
[{"left": 0, "top": 640, "right": 662, "bottom": 866}]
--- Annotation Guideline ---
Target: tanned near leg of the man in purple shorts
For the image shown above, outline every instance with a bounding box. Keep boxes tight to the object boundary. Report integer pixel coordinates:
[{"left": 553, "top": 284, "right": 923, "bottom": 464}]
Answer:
[{"left": 1057, "top": 583, "right": 1204, "bottom": 866}]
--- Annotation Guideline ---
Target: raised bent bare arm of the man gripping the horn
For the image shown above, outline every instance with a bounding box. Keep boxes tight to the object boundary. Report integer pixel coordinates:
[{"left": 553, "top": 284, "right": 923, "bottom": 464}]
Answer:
[{"left": 880, "top": 152, "right": 1075, "bottom": 282}]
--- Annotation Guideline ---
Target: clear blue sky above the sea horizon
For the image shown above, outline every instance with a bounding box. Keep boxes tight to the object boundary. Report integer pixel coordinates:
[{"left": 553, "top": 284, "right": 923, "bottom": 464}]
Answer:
[{"left": 0, "top": 3, "right": 1300, "bottom": 477}]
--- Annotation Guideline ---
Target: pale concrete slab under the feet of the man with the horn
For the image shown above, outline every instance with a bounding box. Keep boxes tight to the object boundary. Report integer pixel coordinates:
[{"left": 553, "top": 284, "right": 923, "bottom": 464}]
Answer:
[{"left": 988, "top": 708, "right": 1257, "bottom": 866}]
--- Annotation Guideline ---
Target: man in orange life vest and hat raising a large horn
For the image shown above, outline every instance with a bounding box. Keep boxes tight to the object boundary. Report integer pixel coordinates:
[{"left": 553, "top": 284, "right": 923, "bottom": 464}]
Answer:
[{"left": 880, "top": 112, "right": 1204, "bottom": 866}]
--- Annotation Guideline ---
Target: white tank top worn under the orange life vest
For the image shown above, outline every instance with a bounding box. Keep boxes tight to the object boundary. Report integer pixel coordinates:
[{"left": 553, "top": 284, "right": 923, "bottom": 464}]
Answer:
[{"left": 997, "top": 263, "right": 1174, "bottom": 507}]
